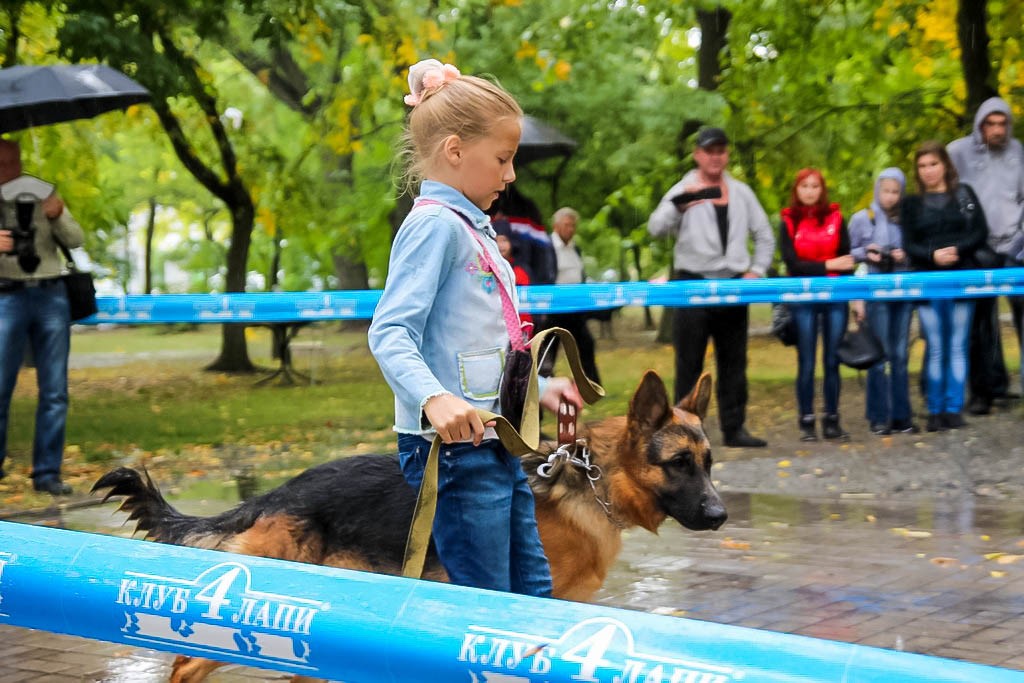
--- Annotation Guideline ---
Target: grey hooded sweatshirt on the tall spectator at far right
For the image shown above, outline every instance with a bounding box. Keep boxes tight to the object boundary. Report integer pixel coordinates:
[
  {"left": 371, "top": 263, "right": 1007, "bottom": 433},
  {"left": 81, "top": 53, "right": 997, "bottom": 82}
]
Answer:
[{"left": 946, "top": 97, "right": 1024, "bottom": 257}]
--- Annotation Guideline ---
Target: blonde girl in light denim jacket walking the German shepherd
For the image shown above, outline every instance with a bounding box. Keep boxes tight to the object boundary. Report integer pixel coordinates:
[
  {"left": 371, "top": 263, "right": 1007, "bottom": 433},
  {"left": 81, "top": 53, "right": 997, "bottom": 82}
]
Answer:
[{"left": 370, "top": 59, "right": 582, "bottom": 596}]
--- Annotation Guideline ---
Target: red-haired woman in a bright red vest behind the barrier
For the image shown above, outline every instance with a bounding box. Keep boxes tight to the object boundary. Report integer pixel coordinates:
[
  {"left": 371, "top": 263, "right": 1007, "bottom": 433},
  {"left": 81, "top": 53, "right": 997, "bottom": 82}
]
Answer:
[{"left": 778, "top": 168, "right": 855, "bottom": 441}]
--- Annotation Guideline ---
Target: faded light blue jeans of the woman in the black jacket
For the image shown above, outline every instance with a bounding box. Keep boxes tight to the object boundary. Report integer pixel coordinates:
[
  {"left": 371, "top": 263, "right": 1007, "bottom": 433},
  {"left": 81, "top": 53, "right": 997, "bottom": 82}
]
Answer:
[{"left": 918, "top": 299, "right": 974, "bottom": 415}]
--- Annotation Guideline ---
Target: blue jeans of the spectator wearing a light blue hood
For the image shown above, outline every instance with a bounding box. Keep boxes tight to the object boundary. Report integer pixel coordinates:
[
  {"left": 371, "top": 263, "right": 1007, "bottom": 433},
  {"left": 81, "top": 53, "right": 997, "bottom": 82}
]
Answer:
[{"left": 865, "top": 301, "right": 913, "bottom": 425}]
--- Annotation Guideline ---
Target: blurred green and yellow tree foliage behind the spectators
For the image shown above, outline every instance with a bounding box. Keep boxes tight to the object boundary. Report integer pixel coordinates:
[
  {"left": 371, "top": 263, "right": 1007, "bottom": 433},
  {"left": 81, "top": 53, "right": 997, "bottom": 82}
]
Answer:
[{"left": 0, "top": 0, "right": 1024, "bottom": 358}]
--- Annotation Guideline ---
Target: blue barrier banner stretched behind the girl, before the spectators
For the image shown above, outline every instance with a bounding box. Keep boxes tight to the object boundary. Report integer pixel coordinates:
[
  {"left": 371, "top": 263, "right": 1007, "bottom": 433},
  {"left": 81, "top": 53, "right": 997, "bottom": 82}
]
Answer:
[{"left": 81, "top": 268, "right": 1024, "bottom": 325}]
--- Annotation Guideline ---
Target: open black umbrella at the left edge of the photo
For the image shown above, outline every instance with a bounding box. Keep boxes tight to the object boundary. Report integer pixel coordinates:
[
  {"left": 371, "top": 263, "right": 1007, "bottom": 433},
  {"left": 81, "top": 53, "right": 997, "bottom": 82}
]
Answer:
[{"left": 0, "top": 65, "right": 150, "bottom": 133}]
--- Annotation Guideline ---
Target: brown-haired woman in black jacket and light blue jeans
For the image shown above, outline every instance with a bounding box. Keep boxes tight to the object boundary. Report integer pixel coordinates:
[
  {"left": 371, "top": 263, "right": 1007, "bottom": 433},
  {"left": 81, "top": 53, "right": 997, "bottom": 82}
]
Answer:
[{"left": 900, "top": 141, "right": 988, "bottom": 432}]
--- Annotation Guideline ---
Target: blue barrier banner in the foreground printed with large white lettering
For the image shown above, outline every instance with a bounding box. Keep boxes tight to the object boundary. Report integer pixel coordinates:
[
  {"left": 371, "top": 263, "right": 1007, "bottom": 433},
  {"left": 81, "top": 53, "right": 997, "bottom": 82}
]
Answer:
[{"left": 0, "top": 522, "right": 1011, "bottom": 683}]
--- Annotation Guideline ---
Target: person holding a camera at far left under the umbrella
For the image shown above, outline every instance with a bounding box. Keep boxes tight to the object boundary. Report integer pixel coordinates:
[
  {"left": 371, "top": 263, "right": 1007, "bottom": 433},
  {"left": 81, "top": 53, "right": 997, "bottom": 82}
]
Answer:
[{"left": 0, "top": 140, "right": 84, "bottom": 496}]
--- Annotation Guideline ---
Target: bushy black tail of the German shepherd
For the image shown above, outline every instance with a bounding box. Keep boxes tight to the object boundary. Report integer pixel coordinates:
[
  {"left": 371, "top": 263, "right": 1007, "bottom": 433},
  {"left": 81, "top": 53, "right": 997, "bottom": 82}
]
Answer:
[{"left": 92, "top": 467, "right": 205, "bottom": 544}]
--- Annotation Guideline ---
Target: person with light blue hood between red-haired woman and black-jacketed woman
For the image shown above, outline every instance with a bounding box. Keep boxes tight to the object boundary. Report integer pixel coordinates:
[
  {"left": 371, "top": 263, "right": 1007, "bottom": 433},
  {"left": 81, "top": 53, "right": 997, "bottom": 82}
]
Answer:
[{"left": 850, "top": 168, "right": 920, "bottom": 435}]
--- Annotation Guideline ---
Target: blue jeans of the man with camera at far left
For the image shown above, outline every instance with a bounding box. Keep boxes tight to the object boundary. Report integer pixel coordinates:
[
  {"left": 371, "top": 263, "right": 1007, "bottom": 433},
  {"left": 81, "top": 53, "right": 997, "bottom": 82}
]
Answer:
[{"left": 0, "top": 280, "right": 71, "bottom": 486}]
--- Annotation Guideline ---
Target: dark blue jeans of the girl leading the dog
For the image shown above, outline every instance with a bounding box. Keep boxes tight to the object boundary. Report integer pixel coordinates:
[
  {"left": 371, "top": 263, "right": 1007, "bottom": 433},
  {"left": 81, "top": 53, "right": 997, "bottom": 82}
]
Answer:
[{"left": 398, "top": 434, "right": 551, "bottom": 597}]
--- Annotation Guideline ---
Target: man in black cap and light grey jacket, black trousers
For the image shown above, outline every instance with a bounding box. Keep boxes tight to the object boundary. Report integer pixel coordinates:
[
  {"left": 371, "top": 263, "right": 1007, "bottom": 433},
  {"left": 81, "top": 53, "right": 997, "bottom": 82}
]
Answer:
[{"left": 647, "top": 128, "right": 775, "bottom": 447}]
